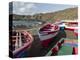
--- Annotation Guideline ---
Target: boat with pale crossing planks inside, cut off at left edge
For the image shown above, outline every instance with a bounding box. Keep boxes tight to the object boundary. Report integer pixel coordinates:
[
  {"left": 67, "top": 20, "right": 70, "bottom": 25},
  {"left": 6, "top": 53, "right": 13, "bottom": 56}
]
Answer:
[{"left": 9, "top": 30, "right": 33, "bottom": 57}]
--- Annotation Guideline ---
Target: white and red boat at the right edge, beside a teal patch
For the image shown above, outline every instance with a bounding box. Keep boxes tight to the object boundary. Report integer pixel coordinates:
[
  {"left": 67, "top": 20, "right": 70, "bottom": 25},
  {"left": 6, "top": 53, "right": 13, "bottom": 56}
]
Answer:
[{"left": 55, "top": 19, "right": 78, "bottom": 36}]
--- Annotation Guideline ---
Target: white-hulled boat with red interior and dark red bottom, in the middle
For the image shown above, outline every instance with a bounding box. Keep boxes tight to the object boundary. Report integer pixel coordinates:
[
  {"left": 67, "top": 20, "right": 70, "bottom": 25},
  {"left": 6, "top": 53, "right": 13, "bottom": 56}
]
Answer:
[{"left": 38, "top": 23, "right": 60, "bottom": 47}]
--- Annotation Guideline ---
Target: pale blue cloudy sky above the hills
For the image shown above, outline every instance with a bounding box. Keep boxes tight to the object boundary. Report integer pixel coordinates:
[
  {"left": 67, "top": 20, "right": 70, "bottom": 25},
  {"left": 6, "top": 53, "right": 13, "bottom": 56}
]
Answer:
[{"left": 9, "top": 2, "right": 77, "bottom": 15}]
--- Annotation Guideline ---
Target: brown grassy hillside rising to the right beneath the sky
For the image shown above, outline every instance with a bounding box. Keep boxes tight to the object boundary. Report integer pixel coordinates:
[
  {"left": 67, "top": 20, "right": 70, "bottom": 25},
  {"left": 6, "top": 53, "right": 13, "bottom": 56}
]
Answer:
[{"left": 10, "top": 7, "right": 78, "bottom": 21}]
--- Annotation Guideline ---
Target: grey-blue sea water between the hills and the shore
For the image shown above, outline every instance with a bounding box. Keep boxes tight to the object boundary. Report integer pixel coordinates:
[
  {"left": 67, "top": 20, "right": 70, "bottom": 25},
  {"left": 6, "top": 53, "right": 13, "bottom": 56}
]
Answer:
[{"left": 13, "top": 20, "right": 45, "bottom": 29}]
